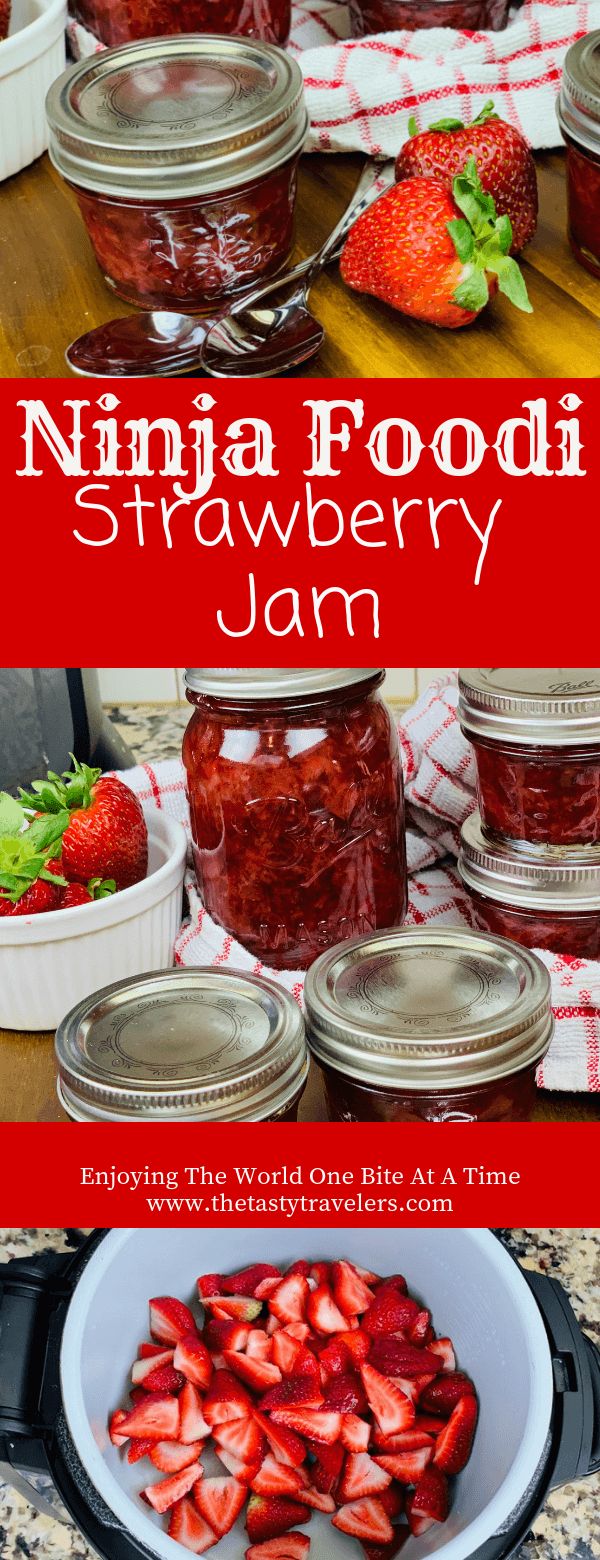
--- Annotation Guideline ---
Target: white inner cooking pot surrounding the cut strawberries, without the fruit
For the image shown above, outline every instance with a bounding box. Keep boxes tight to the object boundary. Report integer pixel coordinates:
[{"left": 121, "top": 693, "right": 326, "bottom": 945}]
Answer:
[{"left": 61, "top": 1228, "right": 553, "bottom": 1560}]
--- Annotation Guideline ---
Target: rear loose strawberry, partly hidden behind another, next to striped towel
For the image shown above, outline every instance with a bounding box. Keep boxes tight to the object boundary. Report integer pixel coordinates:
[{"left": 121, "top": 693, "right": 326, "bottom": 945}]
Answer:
[{"left": 396, "top": 100, "right": 538, "bottom": 254}]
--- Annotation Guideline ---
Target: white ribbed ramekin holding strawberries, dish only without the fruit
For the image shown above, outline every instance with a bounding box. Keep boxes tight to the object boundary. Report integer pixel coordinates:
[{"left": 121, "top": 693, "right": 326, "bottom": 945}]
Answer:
[{"left": 0, "top": 807, "right": 187, "bottom": 1030}]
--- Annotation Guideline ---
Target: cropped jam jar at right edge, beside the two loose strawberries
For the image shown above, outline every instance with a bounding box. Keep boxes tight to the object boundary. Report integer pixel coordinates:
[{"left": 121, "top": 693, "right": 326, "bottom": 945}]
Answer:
[{"left": 556, "top": 31, "right": 600, "bottom": 276}]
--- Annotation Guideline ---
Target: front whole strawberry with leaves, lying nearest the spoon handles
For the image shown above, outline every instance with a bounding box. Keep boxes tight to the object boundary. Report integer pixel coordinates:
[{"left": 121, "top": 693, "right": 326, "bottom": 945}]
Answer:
[{"left": 340, "top": 158, "right": 531, "bottom": 331}]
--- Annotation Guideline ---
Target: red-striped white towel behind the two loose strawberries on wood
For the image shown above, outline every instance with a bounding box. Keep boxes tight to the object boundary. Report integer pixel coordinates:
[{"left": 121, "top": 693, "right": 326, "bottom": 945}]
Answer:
[{"left": 67, "top": 0, "right": 600, "bottom": 158}]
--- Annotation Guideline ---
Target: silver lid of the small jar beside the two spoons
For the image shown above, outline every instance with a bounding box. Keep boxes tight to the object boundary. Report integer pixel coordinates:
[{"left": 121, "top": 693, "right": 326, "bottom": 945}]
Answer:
[{"left": 45, "top": 33, "right": 309, "bottom": 200}]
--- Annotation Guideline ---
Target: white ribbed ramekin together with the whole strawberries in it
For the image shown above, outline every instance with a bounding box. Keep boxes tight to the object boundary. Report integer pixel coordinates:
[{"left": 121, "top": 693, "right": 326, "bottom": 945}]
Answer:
[{"left": 0, "top": 764, "right": 187, "bottom": 1030}]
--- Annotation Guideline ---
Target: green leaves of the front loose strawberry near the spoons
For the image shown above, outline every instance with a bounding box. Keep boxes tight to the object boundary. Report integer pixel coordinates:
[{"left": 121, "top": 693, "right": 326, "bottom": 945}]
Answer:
[{"left": 447, "top": 159, "right": 531, "bottom": 314}]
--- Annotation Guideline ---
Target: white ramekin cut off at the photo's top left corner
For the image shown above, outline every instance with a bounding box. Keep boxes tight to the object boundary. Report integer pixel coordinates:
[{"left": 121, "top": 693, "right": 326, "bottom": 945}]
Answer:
[{"left": 0, "top": 0, "right": 67, "bottom": 179}]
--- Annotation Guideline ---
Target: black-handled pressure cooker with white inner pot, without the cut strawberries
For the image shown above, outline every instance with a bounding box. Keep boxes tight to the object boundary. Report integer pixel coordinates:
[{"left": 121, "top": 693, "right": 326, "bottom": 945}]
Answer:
[{"left": 0, "top": 1228, "right": 600, "bottom": 1560}]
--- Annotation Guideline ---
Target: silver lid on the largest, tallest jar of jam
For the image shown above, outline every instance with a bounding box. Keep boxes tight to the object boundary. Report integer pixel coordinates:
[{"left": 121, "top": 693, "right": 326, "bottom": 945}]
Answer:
[{"left": 185, "top": 666, "right": 383, "bottom": 700}]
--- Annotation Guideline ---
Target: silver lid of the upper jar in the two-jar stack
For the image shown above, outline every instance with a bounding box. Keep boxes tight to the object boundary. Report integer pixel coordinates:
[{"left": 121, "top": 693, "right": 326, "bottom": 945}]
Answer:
[{"left": 458, "top": 666, "right": 600, "bottom": 747}]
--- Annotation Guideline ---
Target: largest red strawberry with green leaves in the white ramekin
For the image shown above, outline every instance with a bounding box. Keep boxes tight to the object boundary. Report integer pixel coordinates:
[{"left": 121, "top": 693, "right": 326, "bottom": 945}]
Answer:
[{"left": 20, "top": 760, "right": 148, "bottom": 889}]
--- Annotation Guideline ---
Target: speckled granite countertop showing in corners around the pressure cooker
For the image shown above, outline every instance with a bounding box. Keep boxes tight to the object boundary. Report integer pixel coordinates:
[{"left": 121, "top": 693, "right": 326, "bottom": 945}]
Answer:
[{"left": 0, "top": 1229, "right": 600, "bottom": 1560}]
